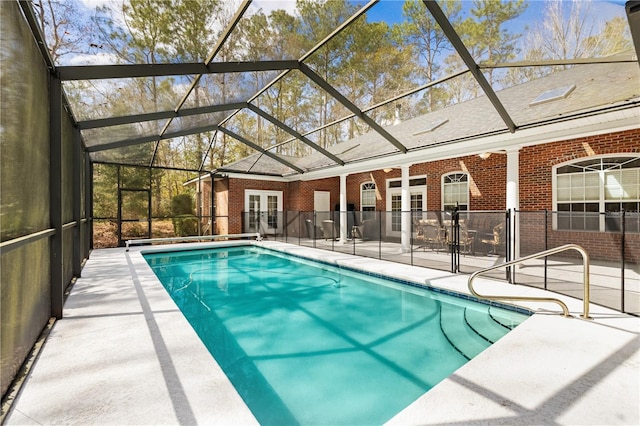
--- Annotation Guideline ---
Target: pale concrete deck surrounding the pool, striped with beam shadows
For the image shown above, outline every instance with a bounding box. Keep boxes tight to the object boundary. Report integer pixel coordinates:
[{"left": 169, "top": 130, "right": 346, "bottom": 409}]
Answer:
[{"left": 4, "top": 241, "right": 640, "bottom": 425}]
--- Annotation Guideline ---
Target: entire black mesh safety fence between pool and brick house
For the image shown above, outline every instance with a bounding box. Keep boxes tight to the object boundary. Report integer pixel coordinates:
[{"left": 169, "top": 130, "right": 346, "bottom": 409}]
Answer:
[{"left": 242, "top": 211, "right": 640, "bottom": 315}]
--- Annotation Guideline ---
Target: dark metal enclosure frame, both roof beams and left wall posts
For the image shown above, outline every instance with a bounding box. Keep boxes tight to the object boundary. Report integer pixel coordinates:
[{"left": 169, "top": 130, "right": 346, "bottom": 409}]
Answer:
[{"left": 6, "top": 0, "right": 640, "bottom": 316}]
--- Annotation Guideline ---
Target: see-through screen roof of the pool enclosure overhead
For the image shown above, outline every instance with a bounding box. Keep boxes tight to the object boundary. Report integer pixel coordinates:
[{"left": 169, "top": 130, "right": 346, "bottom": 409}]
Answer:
[{"left": 27, "top": 0, "right": 640, "bottom": 177}]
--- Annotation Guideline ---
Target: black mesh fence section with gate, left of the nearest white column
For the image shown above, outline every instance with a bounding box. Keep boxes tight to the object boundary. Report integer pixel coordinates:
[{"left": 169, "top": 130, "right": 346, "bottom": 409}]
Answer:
[{"left": 242, "top": 211, "right": 510, "bottom": 278}]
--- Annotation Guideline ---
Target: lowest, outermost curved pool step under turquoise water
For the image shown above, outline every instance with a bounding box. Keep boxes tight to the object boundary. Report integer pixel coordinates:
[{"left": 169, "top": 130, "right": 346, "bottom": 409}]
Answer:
[{"left": 440, "top": 304, "right": 490, "bottom": 359}]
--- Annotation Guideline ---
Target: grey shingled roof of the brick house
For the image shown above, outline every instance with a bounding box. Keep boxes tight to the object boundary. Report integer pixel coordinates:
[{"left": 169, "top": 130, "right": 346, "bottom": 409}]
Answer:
[{"left": 220, "top": 57, "right": 640, "bottom": 174}]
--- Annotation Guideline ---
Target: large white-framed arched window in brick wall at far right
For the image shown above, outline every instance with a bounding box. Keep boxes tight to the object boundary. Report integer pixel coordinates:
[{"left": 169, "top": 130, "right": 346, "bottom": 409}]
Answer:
[{"left": 554, "top": 155, "right": 640, "bottom": 232}]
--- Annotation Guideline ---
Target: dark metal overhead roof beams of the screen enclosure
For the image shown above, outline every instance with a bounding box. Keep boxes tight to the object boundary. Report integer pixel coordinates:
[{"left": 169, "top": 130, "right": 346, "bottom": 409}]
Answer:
[{"left": 20, "top": 0, "right": 638, "bottom": 180}]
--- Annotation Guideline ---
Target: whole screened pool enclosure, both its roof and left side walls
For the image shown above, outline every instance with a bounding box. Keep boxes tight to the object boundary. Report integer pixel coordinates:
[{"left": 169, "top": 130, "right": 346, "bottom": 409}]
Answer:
[{"left": 0, "top": 0, "right": 640, "bottom": 395}]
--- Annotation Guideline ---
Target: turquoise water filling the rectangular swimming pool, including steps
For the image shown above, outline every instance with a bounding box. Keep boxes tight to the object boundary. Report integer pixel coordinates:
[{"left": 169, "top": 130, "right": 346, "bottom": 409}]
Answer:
[{"left": 144, "top": 246, "right": 528, "bottom": 425}]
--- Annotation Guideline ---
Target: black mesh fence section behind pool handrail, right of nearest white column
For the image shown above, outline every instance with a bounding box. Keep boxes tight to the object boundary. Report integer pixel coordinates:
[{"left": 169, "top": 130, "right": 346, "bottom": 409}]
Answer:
[{"left": 513, "top": 211, "right": 640, "bottom": 315}]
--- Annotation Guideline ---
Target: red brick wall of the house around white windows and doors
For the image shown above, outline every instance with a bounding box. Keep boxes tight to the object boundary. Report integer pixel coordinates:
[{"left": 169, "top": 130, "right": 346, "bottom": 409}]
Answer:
[{"left": 218, "top": 129, "right": 640, "bottom": 262}]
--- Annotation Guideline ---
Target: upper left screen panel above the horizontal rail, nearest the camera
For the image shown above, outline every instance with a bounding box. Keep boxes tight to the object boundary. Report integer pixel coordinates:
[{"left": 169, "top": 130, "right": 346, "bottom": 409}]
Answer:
[{"left": 0, "top": 2, "right": 50, "bottom": 241}]
